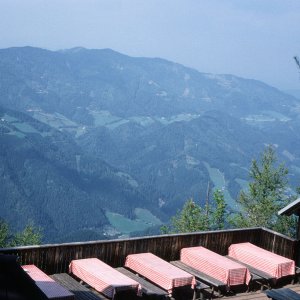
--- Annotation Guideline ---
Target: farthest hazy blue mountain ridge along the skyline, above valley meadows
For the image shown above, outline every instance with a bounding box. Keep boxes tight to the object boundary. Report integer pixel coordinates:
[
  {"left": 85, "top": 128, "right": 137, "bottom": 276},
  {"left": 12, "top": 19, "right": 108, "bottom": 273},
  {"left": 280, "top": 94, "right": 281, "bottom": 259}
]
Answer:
[{"left": 0, "top": 47, "right": 299, "bottom": 119}]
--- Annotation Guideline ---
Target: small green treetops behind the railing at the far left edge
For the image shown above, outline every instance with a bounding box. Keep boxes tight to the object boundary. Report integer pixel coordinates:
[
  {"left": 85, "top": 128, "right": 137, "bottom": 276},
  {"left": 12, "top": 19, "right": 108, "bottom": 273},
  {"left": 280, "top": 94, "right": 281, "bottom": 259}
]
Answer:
[{"left": 0, "top": 221, "right": 42, "bottom": 248}]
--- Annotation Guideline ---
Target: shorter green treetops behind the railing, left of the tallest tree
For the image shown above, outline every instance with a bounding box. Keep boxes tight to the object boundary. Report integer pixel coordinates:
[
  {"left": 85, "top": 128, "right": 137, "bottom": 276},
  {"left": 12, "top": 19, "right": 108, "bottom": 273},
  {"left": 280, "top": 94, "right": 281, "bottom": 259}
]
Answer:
[{"left": 161, "top": 190, "right": 227, "bottom": 233}]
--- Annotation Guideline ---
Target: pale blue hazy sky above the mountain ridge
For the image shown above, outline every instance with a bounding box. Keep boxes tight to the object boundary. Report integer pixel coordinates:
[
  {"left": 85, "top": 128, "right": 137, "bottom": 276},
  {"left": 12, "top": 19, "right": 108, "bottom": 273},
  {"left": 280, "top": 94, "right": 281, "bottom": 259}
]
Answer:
[{"left": 0, "top": 0, "right": 300, "bottom": 89}]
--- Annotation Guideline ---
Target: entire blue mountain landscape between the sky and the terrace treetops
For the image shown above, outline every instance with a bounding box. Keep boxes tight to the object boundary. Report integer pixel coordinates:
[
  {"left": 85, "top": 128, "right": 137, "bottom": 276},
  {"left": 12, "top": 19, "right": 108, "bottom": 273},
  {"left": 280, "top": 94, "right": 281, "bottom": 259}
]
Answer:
[{"left": 0, "top": 47, "right": 300, "bottom": 241}]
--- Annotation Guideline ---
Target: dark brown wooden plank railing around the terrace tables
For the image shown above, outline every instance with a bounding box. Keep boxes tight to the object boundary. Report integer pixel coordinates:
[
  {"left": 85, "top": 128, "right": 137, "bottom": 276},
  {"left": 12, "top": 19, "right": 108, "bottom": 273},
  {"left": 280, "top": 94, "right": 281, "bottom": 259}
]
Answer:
[{"left": 0, "top": 228, "right": 298, "bottom": 274}]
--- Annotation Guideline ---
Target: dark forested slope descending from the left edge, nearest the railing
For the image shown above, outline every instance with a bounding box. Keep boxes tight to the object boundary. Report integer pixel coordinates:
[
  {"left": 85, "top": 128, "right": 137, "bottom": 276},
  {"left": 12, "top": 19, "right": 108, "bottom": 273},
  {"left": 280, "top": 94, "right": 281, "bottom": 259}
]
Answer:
[{"left": 0, "top": 108, "right": 164, "bottom": 241}]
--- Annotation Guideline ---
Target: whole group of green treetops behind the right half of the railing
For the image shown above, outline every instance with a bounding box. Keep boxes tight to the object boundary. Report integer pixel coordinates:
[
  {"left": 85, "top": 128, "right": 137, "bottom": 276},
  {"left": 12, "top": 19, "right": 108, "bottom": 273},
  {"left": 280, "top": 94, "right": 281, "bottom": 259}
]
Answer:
[{"left": 161, "top": 146, "right": 296, "bottom": 236}]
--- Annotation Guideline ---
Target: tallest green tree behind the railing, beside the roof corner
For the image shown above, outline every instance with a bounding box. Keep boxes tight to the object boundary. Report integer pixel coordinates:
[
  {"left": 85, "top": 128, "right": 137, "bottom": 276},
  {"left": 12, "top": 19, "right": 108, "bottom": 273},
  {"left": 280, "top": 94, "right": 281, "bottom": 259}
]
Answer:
[{"left": 231, "top": 146, "right": 295, "bottom": 235}]
